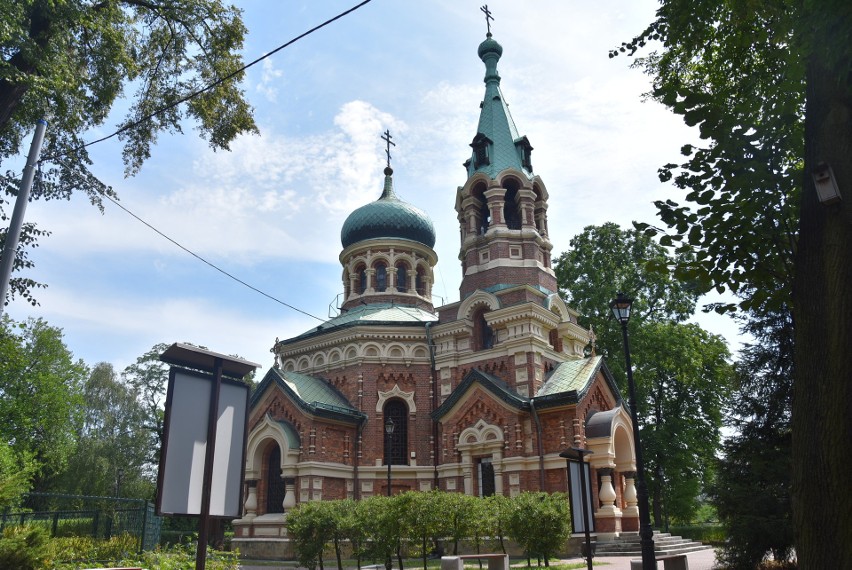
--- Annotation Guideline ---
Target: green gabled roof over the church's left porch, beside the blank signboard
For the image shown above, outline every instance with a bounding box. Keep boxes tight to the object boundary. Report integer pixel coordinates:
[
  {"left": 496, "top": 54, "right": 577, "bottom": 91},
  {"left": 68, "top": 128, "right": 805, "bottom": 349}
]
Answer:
[{"left": 250, "top": 368, "right": 366, "bottom": 422}]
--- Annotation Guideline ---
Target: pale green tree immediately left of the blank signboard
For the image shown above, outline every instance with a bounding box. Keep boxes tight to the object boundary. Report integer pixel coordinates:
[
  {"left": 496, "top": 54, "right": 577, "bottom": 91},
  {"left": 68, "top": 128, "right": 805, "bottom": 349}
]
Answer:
[{"left": 59, "top": 362, "right": 153, "bottom": 499}]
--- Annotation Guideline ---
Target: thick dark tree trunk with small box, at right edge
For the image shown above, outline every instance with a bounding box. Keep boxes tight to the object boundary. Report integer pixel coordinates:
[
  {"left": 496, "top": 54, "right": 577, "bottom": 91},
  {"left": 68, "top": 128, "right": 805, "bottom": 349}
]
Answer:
[{"left": 792, "top": 11, "right": 852, "bottom": 568}]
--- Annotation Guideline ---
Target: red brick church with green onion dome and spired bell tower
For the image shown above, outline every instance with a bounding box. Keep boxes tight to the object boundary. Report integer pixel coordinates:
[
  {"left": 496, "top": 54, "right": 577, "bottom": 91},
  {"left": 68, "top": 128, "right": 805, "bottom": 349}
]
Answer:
[{"left": 234, "top": 33, "right": 638, "bottom": 551}]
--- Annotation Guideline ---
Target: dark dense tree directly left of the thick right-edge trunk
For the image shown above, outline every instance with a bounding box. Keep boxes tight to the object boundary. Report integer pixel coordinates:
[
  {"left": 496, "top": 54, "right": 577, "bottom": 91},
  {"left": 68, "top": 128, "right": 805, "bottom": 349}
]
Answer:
[{"left": 713, "top": 311, "right": 794, "bottom": 570}]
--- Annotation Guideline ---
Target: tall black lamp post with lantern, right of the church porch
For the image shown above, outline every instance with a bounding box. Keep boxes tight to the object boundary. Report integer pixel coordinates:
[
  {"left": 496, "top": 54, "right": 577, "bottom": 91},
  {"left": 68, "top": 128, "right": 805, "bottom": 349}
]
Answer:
[{"left": 609, "top": 293, "right": 657, "bottom": 570}]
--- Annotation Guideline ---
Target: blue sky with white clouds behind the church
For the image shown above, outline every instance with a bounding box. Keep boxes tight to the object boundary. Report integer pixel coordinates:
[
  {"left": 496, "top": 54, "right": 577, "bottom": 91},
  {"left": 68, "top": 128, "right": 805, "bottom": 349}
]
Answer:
[{"left": 7, "top": 0, "right": 737, "bottom": 370}]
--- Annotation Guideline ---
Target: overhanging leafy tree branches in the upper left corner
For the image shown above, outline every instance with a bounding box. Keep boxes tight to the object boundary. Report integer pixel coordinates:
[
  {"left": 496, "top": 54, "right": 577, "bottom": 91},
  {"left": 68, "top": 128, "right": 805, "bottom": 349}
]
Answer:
[{"left": 0, "top": 0, "right": 256, "bottom": 300}]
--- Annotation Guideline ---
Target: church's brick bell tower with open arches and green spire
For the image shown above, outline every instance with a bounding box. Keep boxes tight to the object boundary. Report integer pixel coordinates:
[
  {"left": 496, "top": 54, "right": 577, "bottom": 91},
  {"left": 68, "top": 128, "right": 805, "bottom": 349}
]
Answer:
[{"left": 455, "top": 32, "right": 557, "bottom": 299}]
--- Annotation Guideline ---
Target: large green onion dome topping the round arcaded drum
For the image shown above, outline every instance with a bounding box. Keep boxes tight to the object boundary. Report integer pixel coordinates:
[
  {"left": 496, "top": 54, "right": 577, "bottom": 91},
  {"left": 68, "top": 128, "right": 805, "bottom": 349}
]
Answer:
[{"left": 340, "top": 166, "right": 435, "bottom": 248}]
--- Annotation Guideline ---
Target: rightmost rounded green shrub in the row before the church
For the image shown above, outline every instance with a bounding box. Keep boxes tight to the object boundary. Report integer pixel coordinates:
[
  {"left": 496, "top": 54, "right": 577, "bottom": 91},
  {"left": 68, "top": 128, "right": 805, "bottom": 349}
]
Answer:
[{"left": 507, "top": 492, "right": 571, "bottom": 566}]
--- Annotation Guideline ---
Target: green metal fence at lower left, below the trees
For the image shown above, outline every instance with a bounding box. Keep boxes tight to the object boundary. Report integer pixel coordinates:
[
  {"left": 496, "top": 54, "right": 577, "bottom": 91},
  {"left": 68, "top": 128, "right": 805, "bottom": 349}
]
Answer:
[{"left": 0, "top": 493, "right": 163, "bottom": 552}]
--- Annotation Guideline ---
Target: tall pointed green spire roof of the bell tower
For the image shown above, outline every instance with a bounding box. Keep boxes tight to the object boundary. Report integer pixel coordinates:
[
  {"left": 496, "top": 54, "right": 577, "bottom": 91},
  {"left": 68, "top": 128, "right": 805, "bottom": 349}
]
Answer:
[{"left": 465, "top": 33, "right": 532, "bottom": 179}]
